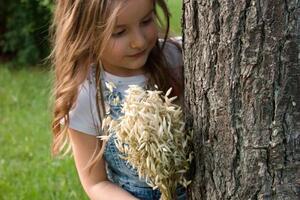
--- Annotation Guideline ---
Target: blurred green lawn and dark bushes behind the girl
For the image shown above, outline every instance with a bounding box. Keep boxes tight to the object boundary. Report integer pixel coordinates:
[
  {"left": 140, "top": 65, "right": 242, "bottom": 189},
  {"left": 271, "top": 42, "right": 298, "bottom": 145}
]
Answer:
[{"left": 0, "top": 0, "right": 182, "bottom": 200}]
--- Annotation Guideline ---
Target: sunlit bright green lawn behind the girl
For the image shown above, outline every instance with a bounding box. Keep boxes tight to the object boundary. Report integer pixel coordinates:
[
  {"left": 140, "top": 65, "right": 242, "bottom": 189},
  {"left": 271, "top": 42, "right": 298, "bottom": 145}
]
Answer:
[{"left": 0, "top": 0, "right": 181, "bottom": 200}]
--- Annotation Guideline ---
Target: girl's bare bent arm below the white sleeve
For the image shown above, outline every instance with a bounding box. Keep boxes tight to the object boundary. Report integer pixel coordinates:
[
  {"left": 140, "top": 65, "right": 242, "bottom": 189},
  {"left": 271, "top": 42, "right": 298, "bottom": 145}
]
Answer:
[{"left": 69, "top": 129, "right": 137, "bottom": 200}]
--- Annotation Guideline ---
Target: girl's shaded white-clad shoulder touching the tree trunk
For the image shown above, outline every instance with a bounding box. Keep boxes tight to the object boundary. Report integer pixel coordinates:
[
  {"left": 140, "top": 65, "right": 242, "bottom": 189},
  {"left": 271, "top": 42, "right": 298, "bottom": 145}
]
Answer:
[{"left": 161, "top": 37, "right": 183, "bottom": 68}]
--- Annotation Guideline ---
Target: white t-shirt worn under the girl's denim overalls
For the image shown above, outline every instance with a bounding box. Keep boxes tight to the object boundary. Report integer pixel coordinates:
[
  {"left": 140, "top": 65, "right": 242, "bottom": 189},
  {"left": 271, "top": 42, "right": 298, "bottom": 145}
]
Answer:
[{"left": 69, "top": 38, "right": 183, "bottom": 136}]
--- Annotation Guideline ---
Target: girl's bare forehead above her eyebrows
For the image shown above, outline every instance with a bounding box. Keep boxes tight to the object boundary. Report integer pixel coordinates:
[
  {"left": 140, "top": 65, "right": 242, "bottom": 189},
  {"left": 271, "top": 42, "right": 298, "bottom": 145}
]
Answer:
[{"left": 116, "top": 0, "right": 154, "bottom": 26}]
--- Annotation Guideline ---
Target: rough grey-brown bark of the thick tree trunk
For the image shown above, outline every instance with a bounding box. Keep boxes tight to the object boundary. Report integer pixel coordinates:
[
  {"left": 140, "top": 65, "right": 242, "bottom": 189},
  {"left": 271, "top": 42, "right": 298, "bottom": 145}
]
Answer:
[{"left": 182, "top": 0, "right": 300, "bottom": 200}]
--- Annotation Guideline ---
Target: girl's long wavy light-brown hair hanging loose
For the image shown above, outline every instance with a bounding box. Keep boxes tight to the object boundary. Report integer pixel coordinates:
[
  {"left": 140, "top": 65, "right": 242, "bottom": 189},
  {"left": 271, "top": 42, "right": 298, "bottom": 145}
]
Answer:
[{"left": 51, "top": 0, "right": 180, "bottom": 169}]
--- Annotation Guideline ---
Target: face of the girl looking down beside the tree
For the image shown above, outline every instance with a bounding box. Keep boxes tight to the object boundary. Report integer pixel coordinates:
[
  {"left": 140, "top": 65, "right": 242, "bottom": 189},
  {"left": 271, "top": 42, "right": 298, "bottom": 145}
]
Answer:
[{"left": 101, "top": 0, "right": 158, "bottom": 76}]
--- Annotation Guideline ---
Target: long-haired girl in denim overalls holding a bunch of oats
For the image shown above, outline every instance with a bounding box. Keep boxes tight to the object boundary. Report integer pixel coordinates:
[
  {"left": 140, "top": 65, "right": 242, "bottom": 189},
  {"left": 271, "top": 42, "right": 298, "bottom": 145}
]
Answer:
[{"left": 52, "top": 0, "right": 186, "bottom": 200}]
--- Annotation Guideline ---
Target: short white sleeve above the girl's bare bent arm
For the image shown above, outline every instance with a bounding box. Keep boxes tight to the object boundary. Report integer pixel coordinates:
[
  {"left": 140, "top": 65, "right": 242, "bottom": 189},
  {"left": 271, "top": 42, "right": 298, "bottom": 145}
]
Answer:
[{"left": 69, "top": 80, "right": 101, "bottom": 136}]
